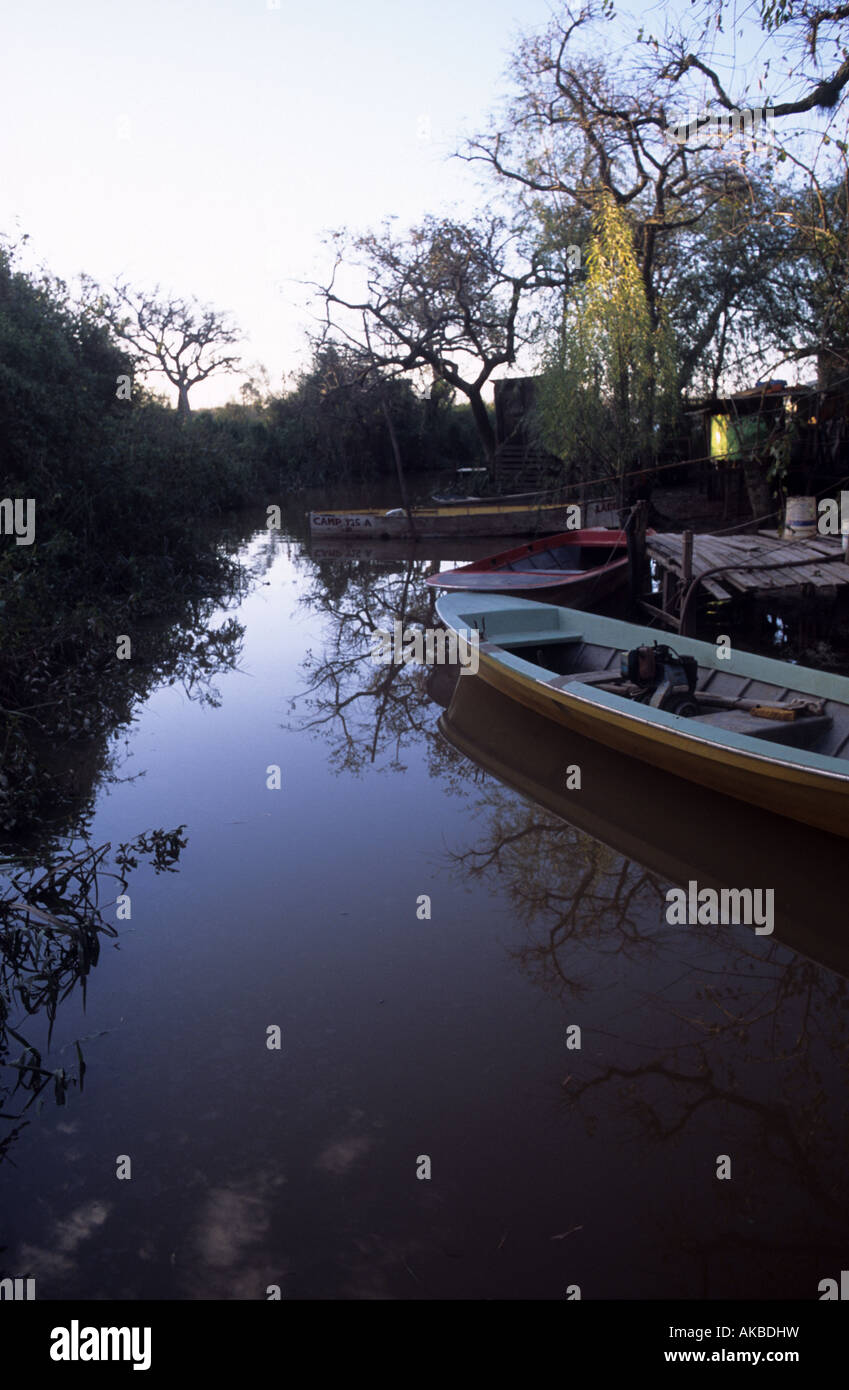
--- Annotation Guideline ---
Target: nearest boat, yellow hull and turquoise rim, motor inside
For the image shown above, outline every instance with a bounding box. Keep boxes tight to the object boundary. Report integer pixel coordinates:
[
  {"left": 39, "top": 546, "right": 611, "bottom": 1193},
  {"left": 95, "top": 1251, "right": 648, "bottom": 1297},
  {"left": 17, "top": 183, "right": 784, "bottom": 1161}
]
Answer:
[{"left": 436, "top": 594, "right": 849, "bottom": 837}]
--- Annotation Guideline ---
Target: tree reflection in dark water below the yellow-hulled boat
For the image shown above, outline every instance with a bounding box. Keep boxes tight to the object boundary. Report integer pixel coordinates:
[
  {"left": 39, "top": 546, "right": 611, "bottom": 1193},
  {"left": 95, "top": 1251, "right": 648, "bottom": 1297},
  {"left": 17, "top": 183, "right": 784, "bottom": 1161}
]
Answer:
[{"left": 449, "top": 778, "right": 849, "bottom": 1287}]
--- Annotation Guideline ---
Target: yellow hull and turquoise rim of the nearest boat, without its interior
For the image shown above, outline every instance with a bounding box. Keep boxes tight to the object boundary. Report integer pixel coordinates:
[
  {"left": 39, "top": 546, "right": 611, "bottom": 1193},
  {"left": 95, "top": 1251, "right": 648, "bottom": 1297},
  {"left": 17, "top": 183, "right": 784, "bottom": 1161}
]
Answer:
[{"left": 436, "top": 595, "right": 849, "bottom": 838}]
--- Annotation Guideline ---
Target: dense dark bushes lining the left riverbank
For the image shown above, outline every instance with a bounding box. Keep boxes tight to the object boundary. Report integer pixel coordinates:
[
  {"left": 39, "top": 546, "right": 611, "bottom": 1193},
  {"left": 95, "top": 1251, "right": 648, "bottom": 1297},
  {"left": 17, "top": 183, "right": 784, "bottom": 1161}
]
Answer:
[{"left": 0, "top": 246, "right": 474, "bottom": 835}]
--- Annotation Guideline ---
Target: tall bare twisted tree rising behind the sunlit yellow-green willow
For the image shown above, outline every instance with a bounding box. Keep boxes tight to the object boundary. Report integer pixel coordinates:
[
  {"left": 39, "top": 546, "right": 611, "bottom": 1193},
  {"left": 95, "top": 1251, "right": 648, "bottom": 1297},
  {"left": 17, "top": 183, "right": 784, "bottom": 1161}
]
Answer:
[{"left": 461, "top": 0, "right": 772, "bottom": 341}]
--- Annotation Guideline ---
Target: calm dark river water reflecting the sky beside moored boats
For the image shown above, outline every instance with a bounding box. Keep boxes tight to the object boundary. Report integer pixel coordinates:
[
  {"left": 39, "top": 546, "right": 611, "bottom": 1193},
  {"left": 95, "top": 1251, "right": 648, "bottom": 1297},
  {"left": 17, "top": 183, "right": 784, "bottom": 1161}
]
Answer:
[{"left": 0, "top": 514, "right": 849, "bottom": 1298}]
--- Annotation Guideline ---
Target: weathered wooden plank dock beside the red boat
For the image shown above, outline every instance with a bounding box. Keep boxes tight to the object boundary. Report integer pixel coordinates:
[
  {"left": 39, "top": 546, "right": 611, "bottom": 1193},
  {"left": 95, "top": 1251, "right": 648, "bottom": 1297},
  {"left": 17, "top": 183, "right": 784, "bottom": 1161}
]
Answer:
[{"left": 641, "top": 531, "right": 849, "bottom": 634}]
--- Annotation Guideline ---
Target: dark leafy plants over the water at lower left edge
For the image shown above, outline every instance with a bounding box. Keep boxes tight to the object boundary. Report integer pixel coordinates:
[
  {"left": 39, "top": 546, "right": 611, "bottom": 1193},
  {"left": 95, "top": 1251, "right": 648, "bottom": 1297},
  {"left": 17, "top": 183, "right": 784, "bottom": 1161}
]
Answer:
[{"left": 0, "top": 826, "right": 186, "bottom": 1161}]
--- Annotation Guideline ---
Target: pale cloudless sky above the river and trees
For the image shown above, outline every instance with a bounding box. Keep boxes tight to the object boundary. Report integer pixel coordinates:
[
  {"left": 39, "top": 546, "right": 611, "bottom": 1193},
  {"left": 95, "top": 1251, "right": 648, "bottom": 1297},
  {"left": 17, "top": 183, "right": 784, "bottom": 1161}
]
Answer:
[{"left": 0, "top": 0, "right": 839, "bottom": 406}]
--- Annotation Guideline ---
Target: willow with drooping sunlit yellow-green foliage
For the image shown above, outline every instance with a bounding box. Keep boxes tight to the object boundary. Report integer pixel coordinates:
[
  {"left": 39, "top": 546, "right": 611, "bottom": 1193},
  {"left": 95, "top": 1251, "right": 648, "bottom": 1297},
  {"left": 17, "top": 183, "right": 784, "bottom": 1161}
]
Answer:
[{"left": 538, "top": 190, "right": 678, "bottom": 505}]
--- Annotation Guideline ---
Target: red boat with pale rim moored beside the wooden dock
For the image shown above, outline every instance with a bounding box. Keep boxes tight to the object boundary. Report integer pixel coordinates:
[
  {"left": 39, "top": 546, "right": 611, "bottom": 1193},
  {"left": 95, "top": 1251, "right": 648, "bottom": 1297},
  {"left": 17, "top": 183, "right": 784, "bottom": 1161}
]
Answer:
[{"left": 428, "top": 527, "right": 628, "bottom": 607}]
